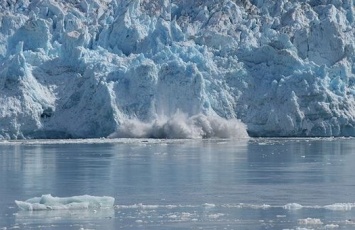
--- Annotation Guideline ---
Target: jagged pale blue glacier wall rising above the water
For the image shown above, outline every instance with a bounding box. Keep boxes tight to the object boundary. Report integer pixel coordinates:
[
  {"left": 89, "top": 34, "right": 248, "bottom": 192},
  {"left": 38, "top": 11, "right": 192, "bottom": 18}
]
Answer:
[{"left": 0, "top": 0, "right": 355, "bottom": 139}]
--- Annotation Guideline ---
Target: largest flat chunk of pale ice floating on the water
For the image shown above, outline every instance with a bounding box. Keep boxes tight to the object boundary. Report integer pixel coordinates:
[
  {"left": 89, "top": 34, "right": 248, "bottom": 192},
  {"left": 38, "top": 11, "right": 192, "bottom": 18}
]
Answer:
[{"left": 15, "top": 194, "right": 115, "bottom": 211}]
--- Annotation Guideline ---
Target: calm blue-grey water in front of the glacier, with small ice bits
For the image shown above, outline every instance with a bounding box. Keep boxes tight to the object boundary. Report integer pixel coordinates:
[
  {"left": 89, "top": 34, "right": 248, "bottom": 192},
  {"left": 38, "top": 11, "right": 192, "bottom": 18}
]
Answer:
[{"left": 0, "top": 139, "right": 355, "bottom": 230}]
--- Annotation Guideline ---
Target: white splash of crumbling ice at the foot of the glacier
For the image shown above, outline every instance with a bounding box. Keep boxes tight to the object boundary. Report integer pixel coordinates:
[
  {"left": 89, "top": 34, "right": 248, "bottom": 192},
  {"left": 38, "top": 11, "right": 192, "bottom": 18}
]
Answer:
[{"left": 110, "top": 111, "right": 248, "bottom": 139}]
